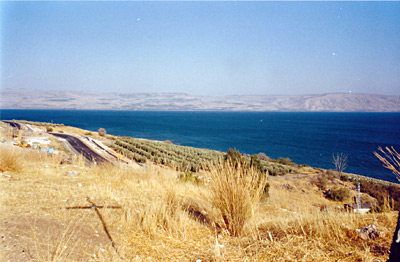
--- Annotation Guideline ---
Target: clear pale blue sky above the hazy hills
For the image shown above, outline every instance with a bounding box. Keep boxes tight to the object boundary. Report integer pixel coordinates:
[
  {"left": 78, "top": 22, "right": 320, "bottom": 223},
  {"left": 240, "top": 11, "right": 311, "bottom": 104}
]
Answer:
[{"left": 0, "top": 1, "right": 400, "bottom": 96}]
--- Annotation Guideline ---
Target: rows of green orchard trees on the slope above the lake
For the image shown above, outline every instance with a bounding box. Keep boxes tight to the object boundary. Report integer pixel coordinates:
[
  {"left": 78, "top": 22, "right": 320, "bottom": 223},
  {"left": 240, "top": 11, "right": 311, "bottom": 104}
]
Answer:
[{"left": 112, "top": 137, "right": 224, "bottom": 172}]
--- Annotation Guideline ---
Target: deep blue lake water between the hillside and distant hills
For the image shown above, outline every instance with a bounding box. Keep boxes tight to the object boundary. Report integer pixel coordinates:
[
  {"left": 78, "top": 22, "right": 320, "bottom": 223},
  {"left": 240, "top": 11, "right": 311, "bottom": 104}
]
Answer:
[{"left": 0, "top": 110, "right": 400, "bottom": 182}]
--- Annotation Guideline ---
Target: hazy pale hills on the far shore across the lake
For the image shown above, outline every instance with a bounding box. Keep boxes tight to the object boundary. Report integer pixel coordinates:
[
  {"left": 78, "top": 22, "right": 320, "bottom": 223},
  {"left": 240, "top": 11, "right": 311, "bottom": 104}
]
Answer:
[{"left": 0, "top": 89, "right": 400, "bottom": 112}]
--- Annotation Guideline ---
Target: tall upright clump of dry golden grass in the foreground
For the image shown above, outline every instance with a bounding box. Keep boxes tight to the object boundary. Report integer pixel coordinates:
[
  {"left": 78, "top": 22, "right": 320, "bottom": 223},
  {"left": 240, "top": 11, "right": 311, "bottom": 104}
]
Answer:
[{"left": 209, "top": 161, "right": 268, "bottom": 236}]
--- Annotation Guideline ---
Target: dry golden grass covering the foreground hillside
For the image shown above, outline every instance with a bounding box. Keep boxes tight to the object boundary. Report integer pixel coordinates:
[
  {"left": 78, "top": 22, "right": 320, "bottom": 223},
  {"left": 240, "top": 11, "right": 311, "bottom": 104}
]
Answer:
[{"left": 0, "top": 144, "right": 396, "bottom": 262}]
